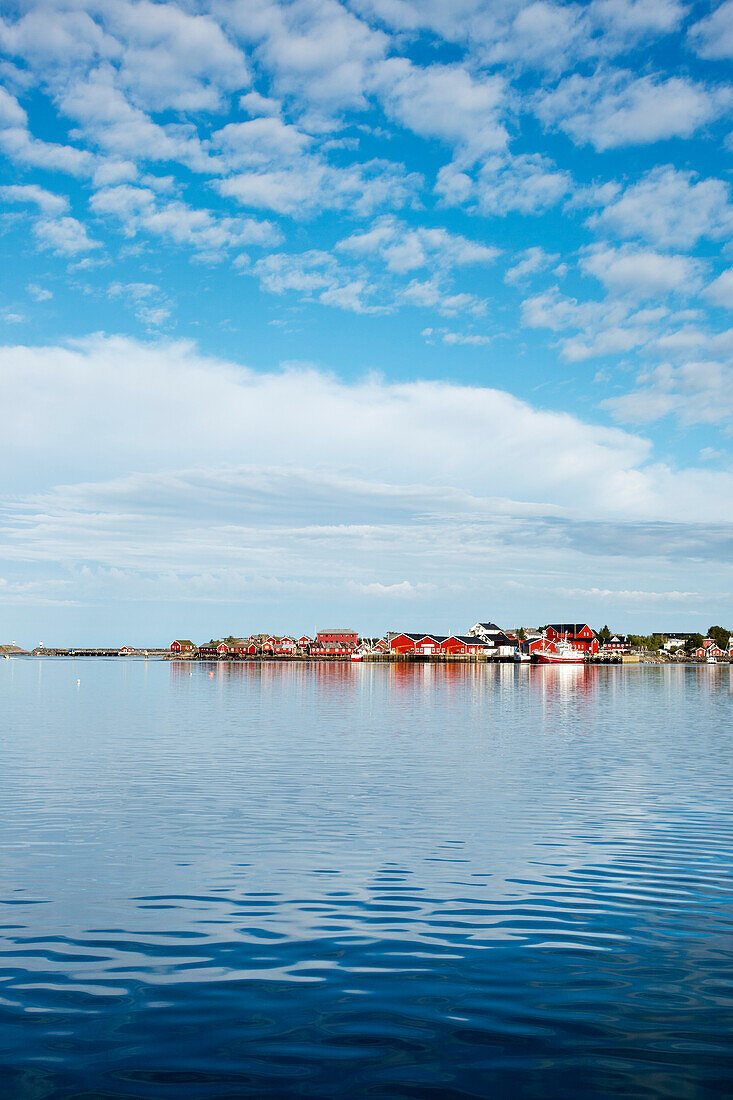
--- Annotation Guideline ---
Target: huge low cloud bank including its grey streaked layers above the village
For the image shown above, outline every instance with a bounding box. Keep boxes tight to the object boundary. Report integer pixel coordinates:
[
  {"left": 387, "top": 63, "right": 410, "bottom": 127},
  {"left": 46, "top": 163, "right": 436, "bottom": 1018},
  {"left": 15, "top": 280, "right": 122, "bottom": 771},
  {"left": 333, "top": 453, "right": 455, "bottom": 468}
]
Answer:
[{"left": 0, "top": 337, "right": 733, "bottom": 634}]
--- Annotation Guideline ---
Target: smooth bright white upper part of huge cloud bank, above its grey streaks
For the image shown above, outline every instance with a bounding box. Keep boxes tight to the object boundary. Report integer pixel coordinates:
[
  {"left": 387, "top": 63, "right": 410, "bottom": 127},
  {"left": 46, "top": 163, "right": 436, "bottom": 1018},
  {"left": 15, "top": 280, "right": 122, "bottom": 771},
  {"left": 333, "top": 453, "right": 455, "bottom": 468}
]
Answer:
[{"left": 0, "top": 337, "right": 704, "bottom": 516}]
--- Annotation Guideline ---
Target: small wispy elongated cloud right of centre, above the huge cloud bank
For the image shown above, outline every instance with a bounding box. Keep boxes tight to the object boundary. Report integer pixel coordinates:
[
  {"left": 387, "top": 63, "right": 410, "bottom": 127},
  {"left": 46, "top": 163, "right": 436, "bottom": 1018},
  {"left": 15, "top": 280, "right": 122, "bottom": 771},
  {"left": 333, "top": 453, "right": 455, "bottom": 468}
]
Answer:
[{"left": 336, "top": 215, "right": 500, "bottom": 274}]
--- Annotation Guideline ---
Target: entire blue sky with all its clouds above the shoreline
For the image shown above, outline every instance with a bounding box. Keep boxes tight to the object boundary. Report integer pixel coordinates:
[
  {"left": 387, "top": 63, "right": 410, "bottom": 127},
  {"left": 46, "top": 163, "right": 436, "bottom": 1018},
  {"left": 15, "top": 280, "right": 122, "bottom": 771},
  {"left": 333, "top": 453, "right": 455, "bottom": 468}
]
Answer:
[{"left": 0, "top": 0, "right": 733, "bottom": 647}]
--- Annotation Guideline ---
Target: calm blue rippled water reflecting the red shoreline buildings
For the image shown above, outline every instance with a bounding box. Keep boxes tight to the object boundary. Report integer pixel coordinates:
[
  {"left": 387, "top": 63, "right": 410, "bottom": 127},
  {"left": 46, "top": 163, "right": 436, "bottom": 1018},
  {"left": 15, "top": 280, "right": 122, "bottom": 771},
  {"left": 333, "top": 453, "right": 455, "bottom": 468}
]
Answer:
[{"left": 0, "top": 659, "right": 733, "bottom": 1100}]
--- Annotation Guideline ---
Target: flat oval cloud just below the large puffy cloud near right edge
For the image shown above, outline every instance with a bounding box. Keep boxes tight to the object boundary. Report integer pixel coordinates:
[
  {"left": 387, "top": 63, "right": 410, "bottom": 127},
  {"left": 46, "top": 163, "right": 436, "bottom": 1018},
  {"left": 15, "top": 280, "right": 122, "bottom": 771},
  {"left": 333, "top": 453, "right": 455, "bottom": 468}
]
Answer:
[{"left": 581, "top": 245, "right": 703, "bottom": 298}]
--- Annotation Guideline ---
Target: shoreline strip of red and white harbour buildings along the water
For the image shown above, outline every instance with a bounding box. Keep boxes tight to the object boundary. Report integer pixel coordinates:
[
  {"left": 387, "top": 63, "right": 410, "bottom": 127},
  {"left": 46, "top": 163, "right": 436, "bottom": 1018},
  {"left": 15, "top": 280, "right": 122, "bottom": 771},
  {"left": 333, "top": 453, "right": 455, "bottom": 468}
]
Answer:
[{"left": 8, "top": 623, "right": 733, "bottom": 664}]
